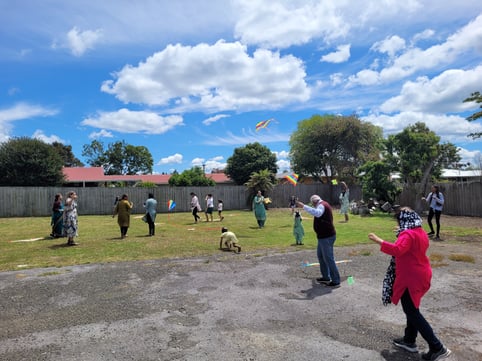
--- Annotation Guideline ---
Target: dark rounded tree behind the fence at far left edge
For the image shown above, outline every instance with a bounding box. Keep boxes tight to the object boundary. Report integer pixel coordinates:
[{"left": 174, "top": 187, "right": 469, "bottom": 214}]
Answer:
[{"left": 0, "top": 137, "right": 64, "bottom": 187}]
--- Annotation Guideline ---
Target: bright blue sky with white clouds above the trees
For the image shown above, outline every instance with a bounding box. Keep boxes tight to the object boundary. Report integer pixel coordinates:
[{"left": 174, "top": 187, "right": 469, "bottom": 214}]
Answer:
[{"left": 0, "top": 0, "right": 482, "bottom": 173}]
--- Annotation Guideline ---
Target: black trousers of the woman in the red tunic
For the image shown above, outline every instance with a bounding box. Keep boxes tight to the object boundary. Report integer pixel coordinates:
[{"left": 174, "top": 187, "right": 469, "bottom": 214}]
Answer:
[{"left": 400, "top": 288, "right": 442, "bottom": 352}]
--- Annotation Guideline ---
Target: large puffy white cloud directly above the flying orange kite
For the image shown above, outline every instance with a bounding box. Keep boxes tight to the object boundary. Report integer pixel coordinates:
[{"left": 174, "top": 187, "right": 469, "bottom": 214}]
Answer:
[{"left": 101, "top": 41, "right": 310, "bottom": 111}]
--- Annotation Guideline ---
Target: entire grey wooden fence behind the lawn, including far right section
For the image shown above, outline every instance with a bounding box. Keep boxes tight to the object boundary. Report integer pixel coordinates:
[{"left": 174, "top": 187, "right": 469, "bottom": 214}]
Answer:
[{"left": 0, "top": 182, "right": 482, "bottom": 217}]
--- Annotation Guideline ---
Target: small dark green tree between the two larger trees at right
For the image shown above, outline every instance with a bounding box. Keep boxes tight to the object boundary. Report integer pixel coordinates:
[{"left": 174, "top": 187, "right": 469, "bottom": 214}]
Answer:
[{"left": 359, "top": 161, "right": 401, "bottom": 204}]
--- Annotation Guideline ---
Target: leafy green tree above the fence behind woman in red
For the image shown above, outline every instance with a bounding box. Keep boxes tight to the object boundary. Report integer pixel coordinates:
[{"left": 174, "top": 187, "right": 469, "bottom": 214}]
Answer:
[{"left": 385, "top": 122, "right": 460, "bottom": 188}]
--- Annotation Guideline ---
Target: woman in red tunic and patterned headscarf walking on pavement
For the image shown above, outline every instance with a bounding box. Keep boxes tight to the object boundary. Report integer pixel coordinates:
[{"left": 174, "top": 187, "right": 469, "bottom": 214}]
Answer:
[{"left": 368, "top": 207, "right": 451, "bottom": 361}]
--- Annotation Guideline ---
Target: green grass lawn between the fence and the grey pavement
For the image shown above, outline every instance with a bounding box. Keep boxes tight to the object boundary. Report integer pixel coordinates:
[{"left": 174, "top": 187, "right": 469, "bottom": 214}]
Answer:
[{"left": 0, "top": 209, "right": 470, "bottom": 271}]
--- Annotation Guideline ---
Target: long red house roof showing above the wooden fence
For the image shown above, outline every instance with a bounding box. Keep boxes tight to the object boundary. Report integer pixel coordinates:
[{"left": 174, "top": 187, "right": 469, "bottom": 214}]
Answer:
[{"left": 63, "top": 167, "right": 232, "bottom": 184}]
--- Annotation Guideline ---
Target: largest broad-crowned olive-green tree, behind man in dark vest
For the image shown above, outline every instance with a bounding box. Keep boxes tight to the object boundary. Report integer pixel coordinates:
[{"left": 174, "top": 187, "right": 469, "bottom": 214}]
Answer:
[{"left": 289, "top": 115, "right": 382, "bottom": 182}]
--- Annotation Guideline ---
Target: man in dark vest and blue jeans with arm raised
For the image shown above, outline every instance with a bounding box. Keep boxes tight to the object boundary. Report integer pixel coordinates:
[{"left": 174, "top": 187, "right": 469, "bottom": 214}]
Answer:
[{"left": 296, "top": 194, "right": 340, "bottom": 288}]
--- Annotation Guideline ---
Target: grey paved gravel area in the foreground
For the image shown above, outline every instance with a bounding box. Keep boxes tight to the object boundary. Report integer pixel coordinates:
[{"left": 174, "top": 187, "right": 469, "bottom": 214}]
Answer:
[{"left": 0, "top": 242, "right": 482, "bottom": 361}]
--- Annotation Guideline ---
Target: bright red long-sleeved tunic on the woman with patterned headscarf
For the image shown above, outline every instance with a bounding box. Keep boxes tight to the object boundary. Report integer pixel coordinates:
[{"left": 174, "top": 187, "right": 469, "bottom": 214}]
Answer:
[{"left": 380, "top": 227, "right": 432, "bottom": 308}]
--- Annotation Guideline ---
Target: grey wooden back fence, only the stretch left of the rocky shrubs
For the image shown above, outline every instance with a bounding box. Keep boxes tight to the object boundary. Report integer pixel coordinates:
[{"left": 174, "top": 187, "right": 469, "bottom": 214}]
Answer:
[{"left": 0, "top": 184, "right": 361, "bottom": 217}]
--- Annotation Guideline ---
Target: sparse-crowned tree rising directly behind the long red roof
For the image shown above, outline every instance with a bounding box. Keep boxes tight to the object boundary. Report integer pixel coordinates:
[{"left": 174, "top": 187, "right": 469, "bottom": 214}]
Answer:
[{"left": 82, "top": 140, "right": 154, "bottom": 175}]
